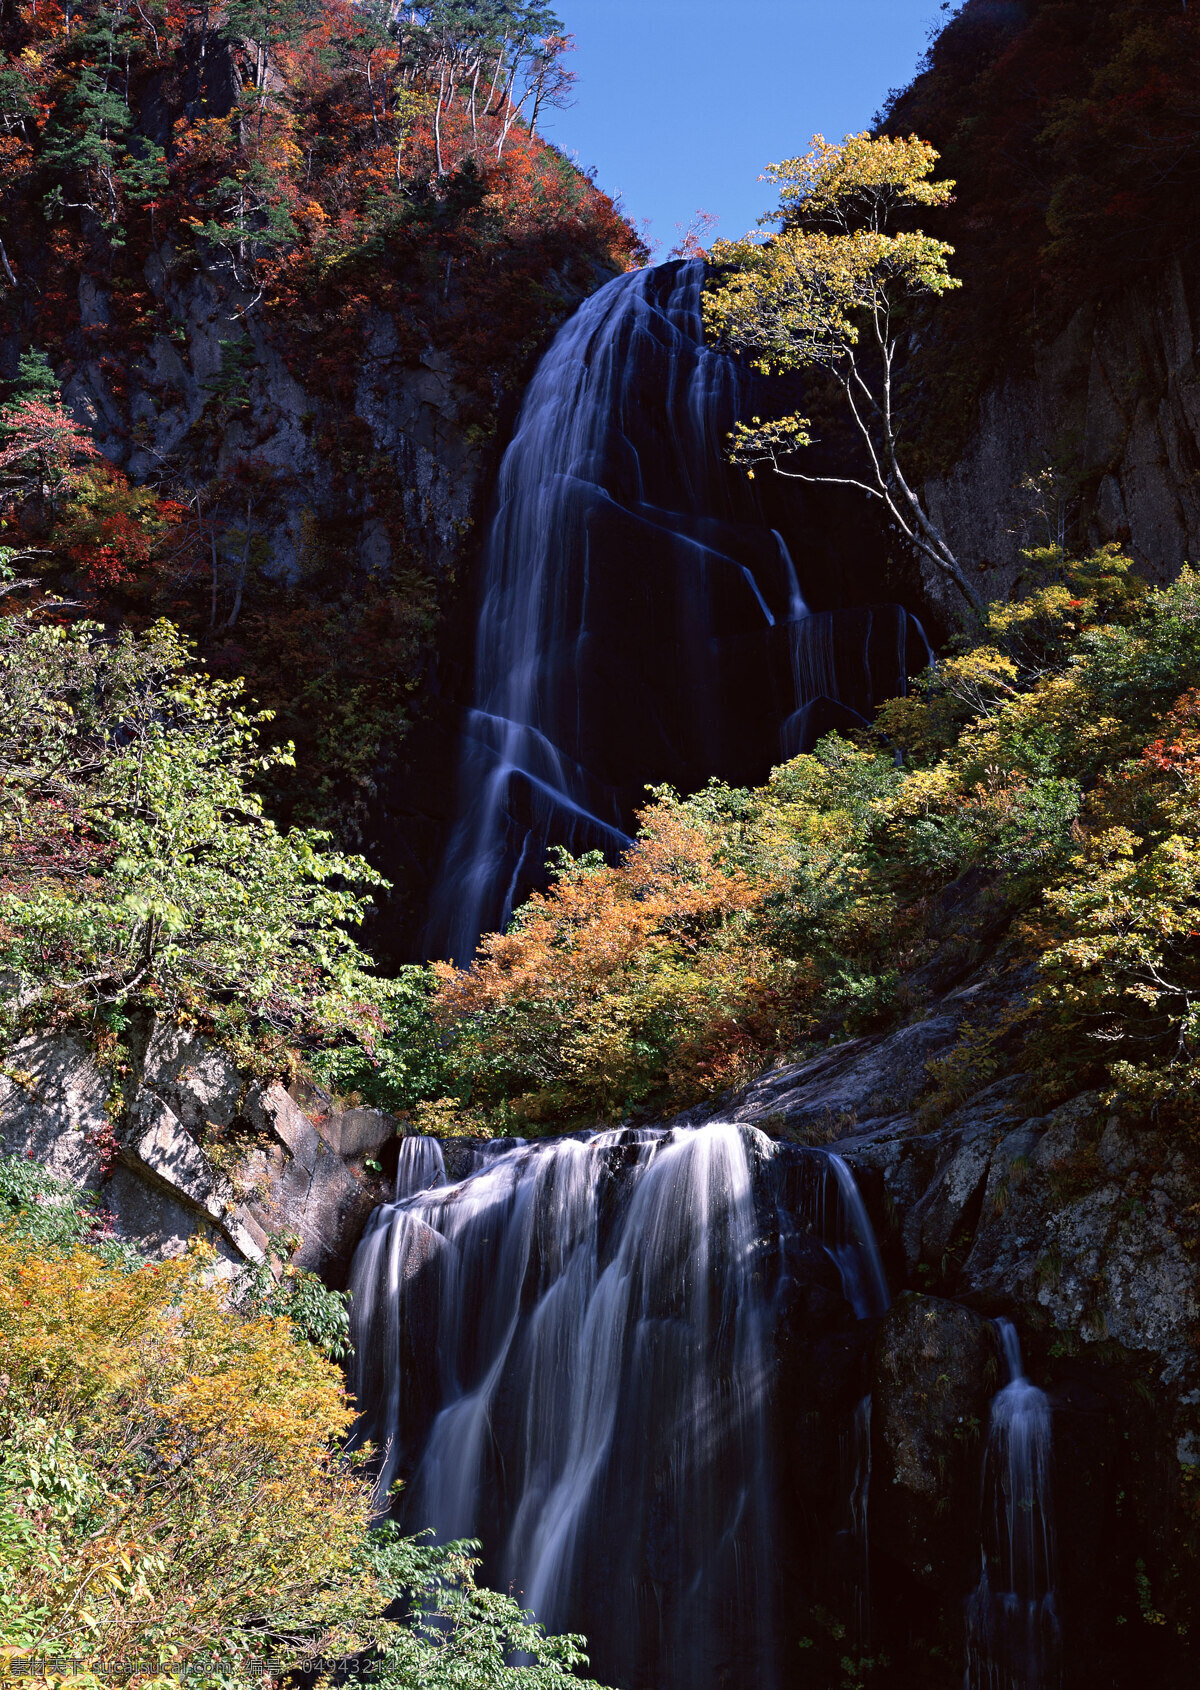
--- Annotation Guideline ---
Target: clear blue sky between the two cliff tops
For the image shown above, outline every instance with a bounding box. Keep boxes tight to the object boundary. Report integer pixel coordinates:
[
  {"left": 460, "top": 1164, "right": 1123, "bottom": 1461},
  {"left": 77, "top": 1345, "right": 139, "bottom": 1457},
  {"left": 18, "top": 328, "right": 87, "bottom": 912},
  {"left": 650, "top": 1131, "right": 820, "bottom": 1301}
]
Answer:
[{"left": 543, "top": 0, "right": 943, "bottom": 257}]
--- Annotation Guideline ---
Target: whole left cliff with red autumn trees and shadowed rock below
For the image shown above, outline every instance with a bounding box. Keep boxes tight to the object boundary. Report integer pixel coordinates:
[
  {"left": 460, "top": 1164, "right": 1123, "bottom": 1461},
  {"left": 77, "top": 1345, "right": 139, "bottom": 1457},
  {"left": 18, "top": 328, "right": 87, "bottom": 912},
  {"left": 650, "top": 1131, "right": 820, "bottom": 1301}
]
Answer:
[{"left": 0, "top": 0, "right": 641, "bottom": 837}]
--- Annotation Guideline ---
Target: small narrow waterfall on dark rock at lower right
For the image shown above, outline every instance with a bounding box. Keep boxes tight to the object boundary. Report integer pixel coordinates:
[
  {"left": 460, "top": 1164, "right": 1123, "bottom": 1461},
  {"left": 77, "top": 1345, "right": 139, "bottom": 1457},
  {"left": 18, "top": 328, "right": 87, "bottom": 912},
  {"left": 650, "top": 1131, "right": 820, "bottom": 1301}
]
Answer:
[{"left": 967, "top": 1320, "right": 1060, "bottom": 1690}]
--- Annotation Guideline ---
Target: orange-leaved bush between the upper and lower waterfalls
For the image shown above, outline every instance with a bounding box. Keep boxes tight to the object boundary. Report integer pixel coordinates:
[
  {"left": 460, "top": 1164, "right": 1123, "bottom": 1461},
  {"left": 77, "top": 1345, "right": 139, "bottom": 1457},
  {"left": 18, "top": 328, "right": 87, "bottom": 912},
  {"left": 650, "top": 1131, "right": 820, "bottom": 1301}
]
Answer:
[{"left": 434, "top": 794, "right": 807, "bottom": 1131}]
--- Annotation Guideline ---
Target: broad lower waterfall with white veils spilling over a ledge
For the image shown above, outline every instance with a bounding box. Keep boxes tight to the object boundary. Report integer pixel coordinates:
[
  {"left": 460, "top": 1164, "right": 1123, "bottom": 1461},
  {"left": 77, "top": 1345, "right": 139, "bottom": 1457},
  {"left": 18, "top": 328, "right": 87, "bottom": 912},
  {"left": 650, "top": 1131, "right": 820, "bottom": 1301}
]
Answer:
[{"left": 352, "top": 1124, "right": 886, "bottom": 1690}]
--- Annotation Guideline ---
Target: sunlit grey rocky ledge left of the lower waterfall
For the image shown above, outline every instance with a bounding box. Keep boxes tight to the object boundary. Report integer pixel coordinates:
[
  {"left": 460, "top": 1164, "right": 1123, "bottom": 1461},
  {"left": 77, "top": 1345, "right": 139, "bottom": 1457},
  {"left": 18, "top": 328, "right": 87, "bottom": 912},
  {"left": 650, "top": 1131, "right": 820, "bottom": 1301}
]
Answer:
[{"left": 0, "top": 1021, "right": 401, "bottom": 1286}]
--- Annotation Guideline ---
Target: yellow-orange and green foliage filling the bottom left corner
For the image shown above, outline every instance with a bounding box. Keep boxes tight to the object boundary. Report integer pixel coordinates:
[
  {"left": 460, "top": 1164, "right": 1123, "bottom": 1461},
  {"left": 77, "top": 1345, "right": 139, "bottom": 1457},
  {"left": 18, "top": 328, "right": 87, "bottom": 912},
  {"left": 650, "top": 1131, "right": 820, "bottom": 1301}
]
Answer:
[{"left": 0, "top": 1158, "right": 611, "bottom": 1690}]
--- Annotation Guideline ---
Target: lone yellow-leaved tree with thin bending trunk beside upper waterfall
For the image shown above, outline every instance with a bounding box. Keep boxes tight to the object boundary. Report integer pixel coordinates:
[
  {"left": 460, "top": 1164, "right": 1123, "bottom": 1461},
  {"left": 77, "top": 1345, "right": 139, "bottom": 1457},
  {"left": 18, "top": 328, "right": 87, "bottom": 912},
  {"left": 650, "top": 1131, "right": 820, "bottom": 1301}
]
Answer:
[{"left": 705, "top": 134, "right": 982, "bottom": 610}]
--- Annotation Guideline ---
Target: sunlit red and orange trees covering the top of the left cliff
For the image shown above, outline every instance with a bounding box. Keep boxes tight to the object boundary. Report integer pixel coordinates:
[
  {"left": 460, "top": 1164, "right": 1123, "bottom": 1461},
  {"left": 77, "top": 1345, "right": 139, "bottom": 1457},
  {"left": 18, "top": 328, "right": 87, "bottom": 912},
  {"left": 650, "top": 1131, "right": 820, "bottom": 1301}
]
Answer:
[{"left": 0, "top": 0, "right": 639, "bottom": 409}]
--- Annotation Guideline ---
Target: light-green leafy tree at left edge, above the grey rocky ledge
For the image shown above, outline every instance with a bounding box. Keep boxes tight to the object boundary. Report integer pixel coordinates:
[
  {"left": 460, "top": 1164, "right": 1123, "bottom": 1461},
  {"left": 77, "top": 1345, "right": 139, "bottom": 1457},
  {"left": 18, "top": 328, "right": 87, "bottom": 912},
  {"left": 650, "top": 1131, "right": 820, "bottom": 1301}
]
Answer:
[{"left": 0, "top": 601, "right": 384, "bottom": 1028}]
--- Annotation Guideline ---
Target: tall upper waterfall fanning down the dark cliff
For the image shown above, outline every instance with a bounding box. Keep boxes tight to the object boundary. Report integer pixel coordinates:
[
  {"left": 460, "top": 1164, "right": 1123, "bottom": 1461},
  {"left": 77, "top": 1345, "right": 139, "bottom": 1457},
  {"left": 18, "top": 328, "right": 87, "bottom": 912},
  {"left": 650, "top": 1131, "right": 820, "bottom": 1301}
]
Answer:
[{"left": 424, "top": 260, "right": 928, "bottom": 962}]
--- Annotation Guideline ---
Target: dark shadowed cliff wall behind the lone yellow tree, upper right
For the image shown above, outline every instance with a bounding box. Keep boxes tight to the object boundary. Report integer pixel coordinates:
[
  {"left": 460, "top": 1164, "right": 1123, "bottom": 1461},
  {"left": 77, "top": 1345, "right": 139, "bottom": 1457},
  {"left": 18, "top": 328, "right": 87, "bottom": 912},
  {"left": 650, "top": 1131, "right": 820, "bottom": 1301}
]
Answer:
[{"left": 877, "top": 0, "right": 1200, "bottom": 621}]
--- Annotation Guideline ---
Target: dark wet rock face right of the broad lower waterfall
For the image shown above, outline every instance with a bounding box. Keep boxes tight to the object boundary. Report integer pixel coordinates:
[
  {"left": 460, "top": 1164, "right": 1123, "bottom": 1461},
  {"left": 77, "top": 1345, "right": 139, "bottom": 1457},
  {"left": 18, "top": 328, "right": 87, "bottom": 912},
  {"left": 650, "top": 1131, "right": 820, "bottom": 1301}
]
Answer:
[{"left": 690, "top": 987, "right": 1200, "bottom": 1690}]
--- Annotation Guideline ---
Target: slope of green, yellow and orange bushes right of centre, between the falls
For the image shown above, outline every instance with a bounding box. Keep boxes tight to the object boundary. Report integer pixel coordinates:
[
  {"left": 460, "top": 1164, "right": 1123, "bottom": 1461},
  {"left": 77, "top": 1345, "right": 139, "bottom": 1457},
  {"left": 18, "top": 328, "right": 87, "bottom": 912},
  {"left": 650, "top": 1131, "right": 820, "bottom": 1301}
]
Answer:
[{"left": 429, "top": 546, "right": 1200, "bottom": 1131}]
